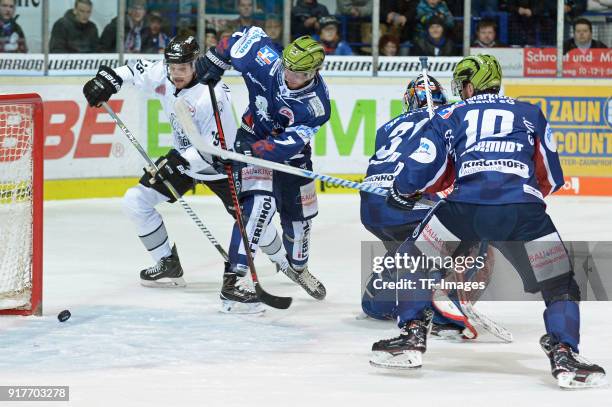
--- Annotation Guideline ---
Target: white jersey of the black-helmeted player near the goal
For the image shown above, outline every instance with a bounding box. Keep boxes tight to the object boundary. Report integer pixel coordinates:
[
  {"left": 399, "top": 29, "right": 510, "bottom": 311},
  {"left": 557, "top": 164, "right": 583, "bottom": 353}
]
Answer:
[{"left": 115, "top": 60, "right": 237, "bottom": 181}]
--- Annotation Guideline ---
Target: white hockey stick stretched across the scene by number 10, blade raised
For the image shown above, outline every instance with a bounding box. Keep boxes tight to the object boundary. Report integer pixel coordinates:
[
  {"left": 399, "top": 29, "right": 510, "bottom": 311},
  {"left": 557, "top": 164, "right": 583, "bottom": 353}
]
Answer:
[{"left": 166, "top": 111, "right": 435, "bottom": 206}]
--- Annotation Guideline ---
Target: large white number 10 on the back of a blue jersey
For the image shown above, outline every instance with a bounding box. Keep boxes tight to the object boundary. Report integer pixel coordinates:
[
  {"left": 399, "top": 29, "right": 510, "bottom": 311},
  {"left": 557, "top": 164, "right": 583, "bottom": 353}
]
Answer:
[{"left": 463, "top": 109, "right": 514, "bottom": 148}]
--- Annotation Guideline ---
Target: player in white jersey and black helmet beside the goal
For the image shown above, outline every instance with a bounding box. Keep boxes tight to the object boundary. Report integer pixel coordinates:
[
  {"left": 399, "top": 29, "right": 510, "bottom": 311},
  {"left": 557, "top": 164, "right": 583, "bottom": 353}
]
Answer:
[{"left": 83, "top": 35, "right": 276, "bottom": 313}]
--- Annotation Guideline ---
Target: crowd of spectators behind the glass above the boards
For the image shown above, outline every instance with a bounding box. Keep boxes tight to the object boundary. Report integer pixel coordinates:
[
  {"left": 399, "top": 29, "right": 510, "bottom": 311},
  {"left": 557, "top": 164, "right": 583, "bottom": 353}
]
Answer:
[{"left": 0, "top": 0, "right": 612, "bottom": 56}]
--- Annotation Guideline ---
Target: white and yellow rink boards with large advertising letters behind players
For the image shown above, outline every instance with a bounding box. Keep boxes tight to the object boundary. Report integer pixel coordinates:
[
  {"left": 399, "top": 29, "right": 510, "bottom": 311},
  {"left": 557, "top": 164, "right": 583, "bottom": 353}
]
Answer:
[{"left": 0, "top": 77, "right": 612, "bottom": 199}]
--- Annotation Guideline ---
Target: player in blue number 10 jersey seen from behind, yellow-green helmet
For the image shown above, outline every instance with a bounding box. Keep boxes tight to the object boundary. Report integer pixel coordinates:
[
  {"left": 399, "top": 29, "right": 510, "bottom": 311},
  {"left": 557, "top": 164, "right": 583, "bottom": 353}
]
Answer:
[{"left": 370, "top": 55, "right": 606, "bottom": 388}]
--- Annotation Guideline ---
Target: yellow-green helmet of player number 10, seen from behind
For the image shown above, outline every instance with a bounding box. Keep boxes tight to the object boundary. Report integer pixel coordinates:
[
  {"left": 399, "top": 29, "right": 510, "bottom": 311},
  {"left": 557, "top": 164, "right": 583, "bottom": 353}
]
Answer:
[{"left": 452, "top": 54, "right": 502, "bottom": 96}]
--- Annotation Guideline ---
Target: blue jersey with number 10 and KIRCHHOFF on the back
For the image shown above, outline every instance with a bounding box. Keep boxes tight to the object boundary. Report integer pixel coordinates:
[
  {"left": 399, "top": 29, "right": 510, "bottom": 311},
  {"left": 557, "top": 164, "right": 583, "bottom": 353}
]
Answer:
[{"left": 396, "top": 94, "right": 564, "bottom": 205}]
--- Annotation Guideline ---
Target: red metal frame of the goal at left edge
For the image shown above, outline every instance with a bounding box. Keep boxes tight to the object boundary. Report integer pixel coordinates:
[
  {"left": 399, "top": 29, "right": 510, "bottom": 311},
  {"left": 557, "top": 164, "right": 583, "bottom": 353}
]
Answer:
[{"left": 0, "top": 93, "right": 44, "bottom": 316}]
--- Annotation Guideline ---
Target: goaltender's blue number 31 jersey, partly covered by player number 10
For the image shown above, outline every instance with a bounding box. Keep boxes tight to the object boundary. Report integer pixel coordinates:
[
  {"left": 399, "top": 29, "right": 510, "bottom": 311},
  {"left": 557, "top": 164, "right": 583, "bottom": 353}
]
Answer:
[{"left": 360, "top": 109, "right": 438, "bottom": 227}]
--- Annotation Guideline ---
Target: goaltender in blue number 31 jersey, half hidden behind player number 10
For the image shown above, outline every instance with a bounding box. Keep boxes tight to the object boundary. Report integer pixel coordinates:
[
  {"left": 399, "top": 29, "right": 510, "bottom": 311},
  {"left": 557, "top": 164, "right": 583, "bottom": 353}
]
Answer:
[{"left": 361, "top": 75, "right": 477, "bottom": 339}]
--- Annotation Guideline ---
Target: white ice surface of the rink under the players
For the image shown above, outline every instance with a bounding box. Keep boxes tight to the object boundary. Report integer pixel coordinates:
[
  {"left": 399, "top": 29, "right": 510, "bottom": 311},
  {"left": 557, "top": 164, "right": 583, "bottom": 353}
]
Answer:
[{"left": 0, "top": 195, "right": 612, "bottom": 407}]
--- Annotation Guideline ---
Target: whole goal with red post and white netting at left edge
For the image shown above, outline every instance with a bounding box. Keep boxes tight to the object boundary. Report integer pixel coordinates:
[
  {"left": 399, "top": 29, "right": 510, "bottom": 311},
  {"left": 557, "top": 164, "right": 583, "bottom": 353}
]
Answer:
[{"left": 0, "top": 93, "right": 44, "bottom": 315}]
